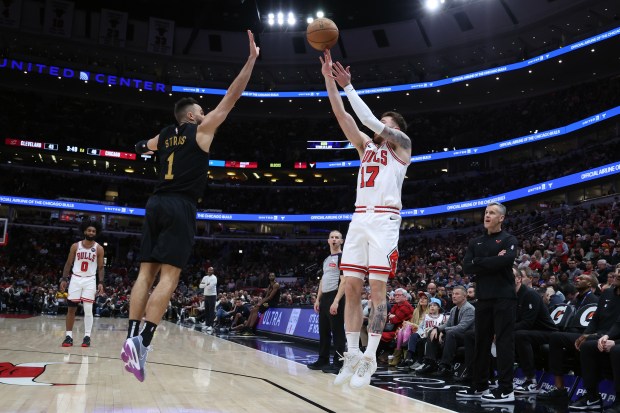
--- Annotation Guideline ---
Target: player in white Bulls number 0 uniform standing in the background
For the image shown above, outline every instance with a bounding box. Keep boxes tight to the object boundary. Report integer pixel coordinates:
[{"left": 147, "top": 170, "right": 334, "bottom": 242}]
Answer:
[{"left": 62, "top": 221, "right": 104, "bottom": 347}]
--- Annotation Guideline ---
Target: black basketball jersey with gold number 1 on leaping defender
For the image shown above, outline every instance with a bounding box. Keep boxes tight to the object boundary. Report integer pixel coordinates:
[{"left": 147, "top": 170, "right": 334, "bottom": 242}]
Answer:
[{"left": 154, "top": 123, "right": 209, "bottom": 201}]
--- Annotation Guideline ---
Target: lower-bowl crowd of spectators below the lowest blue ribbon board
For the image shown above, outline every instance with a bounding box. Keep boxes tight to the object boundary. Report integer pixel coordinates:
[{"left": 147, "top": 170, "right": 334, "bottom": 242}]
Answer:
[{"left": 0, "top": 200, "right": 620, "bottom": 314}]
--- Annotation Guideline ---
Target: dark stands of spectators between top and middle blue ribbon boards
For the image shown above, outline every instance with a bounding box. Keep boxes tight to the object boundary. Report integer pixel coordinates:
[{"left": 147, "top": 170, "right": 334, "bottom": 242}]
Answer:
[{"left": 0, "top": 77, "right": 620, "bottom": 164}]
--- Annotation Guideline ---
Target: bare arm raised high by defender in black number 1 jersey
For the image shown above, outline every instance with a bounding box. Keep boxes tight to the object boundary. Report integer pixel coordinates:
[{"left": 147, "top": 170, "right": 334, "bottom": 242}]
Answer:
[{"left": 198, "top": 30, "right": 260, "bottom": 141}]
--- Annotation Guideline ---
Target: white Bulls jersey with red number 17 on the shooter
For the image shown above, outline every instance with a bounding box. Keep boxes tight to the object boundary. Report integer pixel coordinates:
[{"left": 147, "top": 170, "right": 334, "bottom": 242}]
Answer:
[{"left": 355, "top": 141, "right": 411, "bottom": 210}]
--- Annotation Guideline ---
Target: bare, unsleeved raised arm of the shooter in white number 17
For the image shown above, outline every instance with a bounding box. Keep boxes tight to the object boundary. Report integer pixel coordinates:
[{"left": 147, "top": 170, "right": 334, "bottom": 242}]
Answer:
[{"left": 319, "top": 49, "right": 370, "bottom": 157}]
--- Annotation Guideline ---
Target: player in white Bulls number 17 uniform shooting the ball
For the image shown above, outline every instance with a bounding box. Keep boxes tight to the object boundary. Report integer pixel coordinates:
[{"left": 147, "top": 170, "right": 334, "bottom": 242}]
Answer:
[{"left": 320, "top": 50, "right": 411, "bottom": 388}]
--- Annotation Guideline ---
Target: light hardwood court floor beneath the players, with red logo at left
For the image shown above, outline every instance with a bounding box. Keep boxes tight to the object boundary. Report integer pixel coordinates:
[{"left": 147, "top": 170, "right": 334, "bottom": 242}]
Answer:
[{"left": 0, "top": 316, "right": 450, "bottom": 413}]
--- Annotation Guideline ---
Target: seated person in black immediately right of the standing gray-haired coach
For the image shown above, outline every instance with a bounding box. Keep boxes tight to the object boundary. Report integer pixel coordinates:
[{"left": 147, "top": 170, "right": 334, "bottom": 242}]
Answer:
[{"left": 513, "top": 269, "right": 557, "bottom": 394}]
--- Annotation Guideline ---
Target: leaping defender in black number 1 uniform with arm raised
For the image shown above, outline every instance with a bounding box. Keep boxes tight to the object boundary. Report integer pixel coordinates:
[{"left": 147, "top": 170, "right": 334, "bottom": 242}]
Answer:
[{"left": 121, "top": 30, "right": 259, "bottom": 381}]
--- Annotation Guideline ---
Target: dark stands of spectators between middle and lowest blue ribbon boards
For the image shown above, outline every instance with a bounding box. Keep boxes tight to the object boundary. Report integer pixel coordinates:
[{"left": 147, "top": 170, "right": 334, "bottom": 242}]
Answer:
[{"left": 0, "top": 129, "right": 620, "bottom": 214}]
